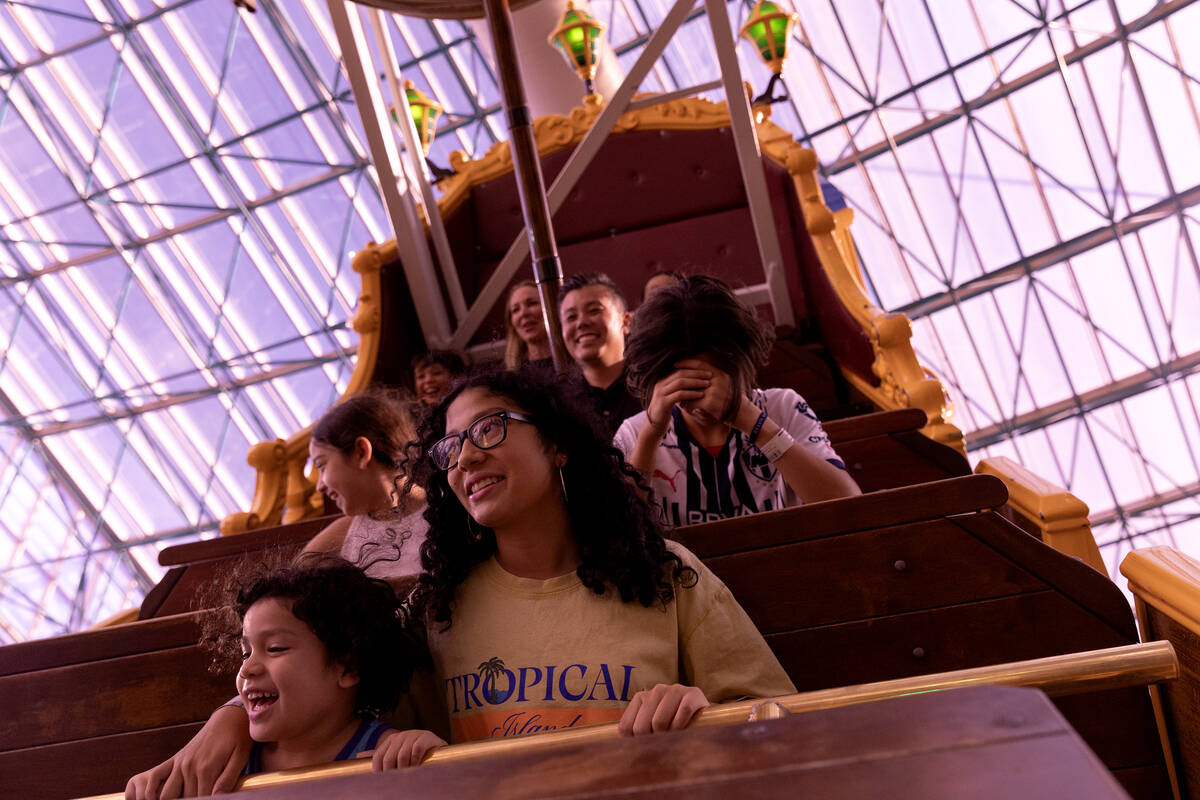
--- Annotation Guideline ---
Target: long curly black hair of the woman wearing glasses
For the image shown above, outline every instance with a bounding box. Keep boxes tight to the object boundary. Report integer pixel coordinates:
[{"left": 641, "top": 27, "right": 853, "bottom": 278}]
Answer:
[{"left": 410, "top": 372, "right": 697, "bottom": 627}]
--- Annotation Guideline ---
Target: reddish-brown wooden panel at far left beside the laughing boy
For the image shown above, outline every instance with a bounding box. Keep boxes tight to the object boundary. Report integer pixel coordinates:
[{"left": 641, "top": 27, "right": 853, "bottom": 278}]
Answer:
[{"left": 0, "top": 614, "right": 233, "bottom": 798}]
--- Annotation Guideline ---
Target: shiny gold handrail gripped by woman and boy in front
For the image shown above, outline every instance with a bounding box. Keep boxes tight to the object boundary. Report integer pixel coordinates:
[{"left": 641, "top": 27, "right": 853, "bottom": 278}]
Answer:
[{"left": 84, "top": 642, "right": 1180, "bottom": 800}]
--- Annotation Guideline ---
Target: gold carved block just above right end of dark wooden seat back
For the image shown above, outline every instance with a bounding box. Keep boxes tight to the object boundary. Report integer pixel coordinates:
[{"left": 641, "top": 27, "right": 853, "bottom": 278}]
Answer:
[{"left": 976, "top": 456, "right": 1109, "bottom": 568}]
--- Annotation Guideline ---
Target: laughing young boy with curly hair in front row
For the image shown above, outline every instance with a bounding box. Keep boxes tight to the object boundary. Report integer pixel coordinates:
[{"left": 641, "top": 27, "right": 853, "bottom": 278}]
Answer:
[{"left": 233, "top": 558, "right": 445, "bottom": 775}]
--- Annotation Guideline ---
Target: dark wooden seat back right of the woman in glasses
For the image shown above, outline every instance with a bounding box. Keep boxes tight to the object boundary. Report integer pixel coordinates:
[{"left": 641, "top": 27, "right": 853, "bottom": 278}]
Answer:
[{"left": 673, "top": 475, "right": 1169, "bottom": 798}]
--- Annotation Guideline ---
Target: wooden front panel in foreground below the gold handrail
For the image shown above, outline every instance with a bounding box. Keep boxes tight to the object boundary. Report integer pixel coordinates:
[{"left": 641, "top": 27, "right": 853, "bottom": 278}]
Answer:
[{"left": 196, "top": 686, "right": 1127, "bottom": 800}]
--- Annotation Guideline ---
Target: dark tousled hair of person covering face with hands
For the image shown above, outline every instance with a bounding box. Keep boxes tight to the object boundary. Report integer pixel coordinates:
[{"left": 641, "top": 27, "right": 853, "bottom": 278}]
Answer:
[{"left": 625, "top": 275, "right": 775, "bottom": 417}]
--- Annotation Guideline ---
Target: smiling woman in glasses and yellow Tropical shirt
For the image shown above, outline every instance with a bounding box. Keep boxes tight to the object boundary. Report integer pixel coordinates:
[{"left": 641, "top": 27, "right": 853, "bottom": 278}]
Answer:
[{"left": 414, "top": 373, "right": 794, "bottom": 741}]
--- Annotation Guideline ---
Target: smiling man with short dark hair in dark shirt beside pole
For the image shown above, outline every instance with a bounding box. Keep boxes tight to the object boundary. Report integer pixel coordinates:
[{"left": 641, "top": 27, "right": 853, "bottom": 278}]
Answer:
[{"left": 558, "top": 272, "right": 642, "bottom": 438}]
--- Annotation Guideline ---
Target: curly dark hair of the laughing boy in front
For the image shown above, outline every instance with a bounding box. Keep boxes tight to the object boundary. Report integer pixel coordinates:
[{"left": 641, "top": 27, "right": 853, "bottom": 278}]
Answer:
[{"left": 206, "top": 553, "right": 428, "bottom": 717}]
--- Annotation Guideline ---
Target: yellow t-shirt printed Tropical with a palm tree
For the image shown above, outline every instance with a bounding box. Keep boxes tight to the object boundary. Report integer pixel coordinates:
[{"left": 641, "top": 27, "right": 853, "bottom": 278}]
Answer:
[{"left": 428, "top": 542, "right": 796, "bottom": 741}]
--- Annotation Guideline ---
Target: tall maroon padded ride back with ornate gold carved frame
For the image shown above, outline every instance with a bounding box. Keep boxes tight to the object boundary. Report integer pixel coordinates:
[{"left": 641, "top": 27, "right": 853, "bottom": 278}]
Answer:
[{"left": 222, "top": 98, "right": 1104, "bottom": 571}]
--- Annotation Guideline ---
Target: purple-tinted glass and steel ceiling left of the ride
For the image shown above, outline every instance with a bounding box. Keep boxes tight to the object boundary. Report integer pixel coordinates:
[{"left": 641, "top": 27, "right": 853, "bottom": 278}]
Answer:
[{"left": 0, "top": 0, "right": 500, "bottom": 642}]
